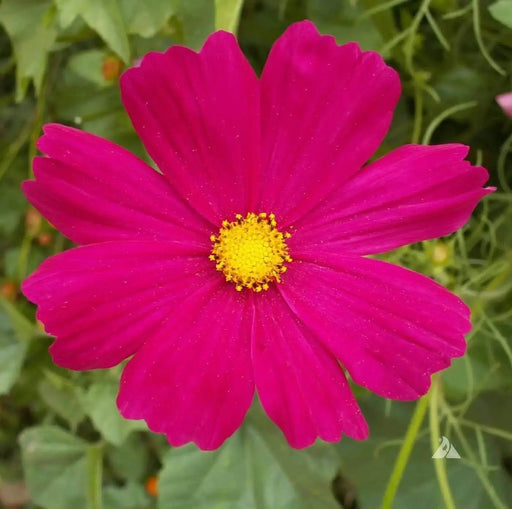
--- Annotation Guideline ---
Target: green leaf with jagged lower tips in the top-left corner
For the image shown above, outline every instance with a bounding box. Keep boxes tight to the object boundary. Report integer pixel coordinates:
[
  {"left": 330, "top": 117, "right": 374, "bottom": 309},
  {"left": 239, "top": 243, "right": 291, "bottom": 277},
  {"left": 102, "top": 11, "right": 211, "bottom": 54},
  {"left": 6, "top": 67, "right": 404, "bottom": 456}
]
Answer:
[{"left": 0, "top": 0, "right": 57, "bottom": 101}]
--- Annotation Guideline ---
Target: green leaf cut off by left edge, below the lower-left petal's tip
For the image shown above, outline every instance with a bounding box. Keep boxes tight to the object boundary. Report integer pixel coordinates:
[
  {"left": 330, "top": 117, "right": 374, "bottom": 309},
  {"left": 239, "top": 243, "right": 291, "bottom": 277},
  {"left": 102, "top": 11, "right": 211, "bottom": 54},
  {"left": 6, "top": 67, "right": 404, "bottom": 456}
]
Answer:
[{"left": 0, "top": 299, "right": 33, "bottom": 394}]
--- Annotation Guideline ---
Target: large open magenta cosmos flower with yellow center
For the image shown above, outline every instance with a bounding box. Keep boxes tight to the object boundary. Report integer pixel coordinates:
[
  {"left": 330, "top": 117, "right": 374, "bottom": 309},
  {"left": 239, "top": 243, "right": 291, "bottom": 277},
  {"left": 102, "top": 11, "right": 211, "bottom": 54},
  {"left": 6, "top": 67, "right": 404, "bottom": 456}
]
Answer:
[{"left": 23, "top": 21, "right": 492, "bottom": 449}]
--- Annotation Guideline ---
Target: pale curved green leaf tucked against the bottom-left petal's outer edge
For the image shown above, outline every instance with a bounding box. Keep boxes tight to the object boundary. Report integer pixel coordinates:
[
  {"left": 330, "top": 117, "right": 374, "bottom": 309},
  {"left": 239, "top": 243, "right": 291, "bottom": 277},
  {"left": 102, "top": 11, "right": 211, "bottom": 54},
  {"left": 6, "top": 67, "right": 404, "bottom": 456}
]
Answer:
[{"left": 83, "top": 380, "right": 147, "bottom": 445}]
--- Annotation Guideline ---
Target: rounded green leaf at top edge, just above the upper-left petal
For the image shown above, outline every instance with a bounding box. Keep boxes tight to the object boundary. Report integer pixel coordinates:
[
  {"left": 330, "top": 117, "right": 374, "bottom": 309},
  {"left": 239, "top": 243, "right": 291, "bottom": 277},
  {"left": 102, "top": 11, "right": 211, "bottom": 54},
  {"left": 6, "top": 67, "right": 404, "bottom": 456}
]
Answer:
[{"left": 120, "top": 0, "right": 174, "bottom": 37}]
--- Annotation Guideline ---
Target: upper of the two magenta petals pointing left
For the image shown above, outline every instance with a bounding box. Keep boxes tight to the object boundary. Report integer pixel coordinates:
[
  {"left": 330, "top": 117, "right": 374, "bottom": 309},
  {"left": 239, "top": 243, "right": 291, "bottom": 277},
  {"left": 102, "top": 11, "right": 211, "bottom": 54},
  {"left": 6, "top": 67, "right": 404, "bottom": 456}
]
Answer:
[{"left": 23, "top": 124, "right": 211, "bottom": 244}]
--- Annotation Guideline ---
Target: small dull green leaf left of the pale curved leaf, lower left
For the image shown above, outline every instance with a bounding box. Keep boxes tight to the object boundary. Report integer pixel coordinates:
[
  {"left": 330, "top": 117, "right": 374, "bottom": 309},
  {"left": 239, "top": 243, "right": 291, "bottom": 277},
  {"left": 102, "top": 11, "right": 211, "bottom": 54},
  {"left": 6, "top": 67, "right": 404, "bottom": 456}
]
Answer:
[{"left": 38, "top": 370, "right": 85, "bottom": 429}]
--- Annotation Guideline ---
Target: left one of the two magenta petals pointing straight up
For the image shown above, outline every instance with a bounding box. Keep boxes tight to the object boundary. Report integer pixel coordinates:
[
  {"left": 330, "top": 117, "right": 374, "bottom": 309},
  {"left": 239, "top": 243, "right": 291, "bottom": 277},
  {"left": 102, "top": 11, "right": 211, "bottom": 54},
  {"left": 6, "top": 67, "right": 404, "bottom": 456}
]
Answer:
[{"left": 121, "top": 32, "right": 260, "bottom": 224}]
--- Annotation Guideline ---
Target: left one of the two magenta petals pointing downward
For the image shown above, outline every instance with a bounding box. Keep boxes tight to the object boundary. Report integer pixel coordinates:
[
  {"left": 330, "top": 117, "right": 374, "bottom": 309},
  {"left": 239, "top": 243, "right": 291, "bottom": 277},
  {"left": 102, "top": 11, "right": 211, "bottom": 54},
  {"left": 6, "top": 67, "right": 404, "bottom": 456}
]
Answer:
[{"left": 118, "top": 280, "right": 254, "bottom": 450}]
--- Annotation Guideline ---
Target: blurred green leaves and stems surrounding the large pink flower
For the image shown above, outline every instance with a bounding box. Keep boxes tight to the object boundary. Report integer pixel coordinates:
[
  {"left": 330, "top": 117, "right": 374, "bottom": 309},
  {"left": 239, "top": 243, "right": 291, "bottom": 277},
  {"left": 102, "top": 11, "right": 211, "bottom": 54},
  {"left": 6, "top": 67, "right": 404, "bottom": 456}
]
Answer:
[{"left": 0, "top": 0, "right": 512, "bottom": 509}]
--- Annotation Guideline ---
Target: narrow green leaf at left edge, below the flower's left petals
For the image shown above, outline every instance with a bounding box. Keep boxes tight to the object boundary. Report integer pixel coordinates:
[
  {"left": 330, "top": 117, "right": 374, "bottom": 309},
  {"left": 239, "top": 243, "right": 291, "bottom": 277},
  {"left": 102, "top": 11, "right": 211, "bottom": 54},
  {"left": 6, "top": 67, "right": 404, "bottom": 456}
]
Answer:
[{"left": 0, "top": 300, "right": 28, "bottom": 394}]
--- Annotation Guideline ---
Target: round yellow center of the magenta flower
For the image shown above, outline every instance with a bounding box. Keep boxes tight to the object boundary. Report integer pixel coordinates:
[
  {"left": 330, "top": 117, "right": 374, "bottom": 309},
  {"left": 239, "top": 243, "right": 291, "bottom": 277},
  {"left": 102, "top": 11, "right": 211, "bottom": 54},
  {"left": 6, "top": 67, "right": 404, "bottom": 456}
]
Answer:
[{"left": 210, "top": 212, "right": 292, "bottom": 292}]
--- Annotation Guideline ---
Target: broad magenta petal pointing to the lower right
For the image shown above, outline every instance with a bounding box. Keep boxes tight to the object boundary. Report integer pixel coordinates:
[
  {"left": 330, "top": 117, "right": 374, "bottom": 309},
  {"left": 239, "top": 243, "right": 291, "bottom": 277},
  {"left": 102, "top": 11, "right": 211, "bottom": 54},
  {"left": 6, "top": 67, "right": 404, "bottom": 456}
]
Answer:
[{"left": 279, "top": 250, "right": 471, "bottom": 400}]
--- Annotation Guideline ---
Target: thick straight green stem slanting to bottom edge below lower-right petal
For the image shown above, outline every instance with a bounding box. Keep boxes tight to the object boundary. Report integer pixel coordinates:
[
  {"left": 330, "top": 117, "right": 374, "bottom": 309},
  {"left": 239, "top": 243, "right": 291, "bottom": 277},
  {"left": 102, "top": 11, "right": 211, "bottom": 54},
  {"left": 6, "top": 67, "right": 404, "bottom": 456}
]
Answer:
[{"left": 382, "top": 393, "right": 430, "bottom": 509}]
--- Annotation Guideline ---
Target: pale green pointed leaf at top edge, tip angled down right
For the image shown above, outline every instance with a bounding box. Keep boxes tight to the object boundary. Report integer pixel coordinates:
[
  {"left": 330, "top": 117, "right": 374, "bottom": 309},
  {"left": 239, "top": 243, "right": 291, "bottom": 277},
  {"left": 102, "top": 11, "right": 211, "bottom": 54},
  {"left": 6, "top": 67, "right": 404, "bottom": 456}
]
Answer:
[{"left": 55, "top": 0, "right": 130, "bottom": 63}]
